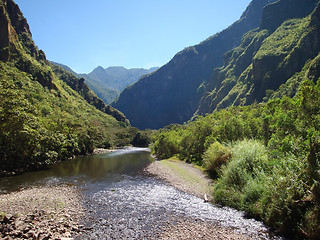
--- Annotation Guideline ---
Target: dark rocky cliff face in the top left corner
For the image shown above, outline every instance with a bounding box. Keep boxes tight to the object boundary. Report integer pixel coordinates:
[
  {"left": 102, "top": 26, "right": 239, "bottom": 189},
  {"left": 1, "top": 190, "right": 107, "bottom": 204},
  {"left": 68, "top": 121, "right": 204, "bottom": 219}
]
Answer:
[{"left": 0, "top": 0, "right": 56, "bottom": 89}]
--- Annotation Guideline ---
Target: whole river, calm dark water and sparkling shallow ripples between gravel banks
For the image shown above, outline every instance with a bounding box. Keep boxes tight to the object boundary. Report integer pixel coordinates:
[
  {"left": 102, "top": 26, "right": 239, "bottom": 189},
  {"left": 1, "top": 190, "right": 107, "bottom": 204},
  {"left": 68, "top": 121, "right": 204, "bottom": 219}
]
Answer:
[{"left": 0, "top": 148, "right": 281, "bottom": 239}]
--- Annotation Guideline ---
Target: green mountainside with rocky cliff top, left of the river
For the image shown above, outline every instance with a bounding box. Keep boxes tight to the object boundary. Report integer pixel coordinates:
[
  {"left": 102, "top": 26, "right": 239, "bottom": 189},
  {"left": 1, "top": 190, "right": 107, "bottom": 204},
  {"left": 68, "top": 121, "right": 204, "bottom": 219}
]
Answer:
[{"left": 0, "top": 0, "right": 132, "bottom": 175}]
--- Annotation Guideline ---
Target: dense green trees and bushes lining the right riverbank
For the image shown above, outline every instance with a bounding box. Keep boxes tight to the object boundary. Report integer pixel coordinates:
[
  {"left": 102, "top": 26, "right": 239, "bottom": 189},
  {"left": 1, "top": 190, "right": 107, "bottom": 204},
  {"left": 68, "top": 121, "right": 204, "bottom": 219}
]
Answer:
[{"left": 152, "top": 80, "right": 320, "bottom": 239}]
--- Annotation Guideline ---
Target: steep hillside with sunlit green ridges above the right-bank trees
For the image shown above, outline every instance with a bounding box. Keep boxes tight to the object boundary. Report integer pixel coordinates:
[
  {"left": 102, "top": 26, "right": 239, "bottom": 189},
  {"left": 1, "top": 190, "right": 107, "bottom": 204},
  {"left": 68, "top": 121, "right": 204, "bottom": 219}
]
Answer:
[{"left": 195, "top": 0, "right": 320, "bottom": 115}]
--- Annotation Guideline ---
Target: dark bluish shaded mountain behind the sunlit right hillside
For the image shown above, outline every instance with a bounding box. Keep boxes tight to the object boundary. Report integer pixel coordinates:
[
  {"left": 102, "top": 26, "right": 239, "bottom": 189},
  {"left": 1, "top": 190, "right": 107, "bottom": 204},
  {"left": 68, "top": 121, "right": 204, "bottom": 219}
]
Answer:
[{"left": 112, "top": 0, "right": 275, "bottom": 129}]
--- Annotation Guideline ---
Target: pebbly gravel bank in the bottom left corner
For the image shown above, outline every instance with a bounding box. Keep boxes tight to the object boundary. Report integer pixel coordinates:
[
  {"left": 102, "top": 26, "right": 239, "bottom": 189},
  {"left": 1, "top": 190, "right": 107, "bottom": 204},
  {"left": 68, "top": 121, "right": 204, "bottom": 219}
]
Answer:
[{"left": 0, "top": 186, "right": 85, "bottom": 240}]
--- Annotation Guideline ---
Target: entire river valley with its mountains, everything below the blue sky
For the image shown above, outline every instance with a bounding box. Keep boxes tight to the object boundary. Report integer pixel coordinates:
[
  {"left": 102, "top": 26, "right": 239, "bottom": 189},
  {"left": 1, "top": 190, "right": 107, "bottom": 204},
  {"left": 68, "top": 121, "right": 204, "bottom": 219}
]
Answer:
[{"left": 0, "top": 0, "right": 320, "bottom": 239}]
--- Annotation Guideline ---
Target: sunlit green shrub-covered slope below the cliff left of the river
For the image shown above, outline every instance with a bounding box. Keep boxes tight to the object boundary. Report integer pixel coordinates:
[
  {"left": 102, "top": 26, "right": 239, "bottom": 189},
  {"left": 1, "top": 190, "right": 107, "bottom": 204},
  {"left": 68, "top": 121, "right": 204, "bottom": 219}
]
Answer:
[{"left": 0, "top": 59, "right": 145, "bottom": 174}]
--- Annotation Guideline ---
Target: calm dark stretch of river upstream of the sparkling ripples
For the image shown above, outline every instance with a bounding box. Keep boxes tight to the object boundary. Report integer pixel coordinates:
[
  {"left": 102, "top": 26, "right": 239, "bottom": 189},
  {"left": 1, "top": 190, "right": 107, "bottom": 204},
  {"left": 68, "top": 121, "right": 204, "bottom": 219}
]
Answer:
[{"left": 0, "top": 148, "right": 152, "bottom": 193}]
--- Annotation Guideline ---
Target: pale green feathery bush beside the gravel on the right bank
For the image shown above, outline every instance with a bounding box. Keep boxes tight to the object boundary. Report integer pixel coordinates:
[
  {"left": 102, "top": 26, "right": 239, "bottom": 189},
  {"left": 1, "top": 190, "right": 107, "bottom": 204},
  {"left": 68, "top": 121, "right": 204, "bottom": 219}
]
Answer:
[{"left": 214, "top": 140, "right": 268, "bottom": 212}]
